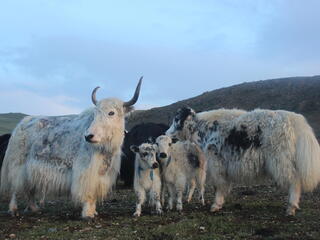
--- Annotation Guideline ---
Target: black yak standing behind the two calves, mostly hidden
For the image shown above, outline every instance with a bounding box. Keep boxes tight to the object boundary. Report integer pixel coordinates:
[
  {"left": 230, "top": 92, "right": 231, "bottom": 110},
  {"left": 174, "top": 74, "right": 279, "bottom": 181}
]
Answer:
[{"left": 120, "top": 123, "right": 169, "bottom": 187}]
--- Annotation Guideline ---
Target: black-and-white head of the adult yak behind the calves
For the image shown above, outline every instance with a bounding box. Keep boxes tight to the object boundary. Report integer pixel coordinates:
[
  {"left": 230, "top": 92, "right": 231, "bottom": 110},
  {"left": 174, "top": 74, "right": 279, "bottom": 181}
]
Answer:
[{"left": 166, "top": 107, "right": 196, "bottom": 141}]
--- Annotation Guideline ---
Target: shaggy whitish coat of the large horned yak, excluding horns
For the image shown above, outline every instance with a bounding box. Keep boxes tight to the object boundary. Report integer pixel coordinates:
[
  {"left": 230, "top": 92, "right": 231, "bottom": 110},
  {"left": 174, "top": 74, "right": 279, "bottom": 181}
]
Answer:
[{"left": 0, "top": 81, "right": 140, "bottom": 218}]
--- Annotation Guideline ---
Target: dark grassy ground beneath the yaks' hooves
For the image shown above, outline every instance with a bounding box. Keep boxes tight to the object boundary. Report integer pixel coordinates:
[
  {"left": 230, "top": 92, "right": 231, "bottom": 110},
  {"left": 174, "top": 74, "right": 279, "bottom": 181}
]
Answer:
[{"left": 0, "top": 184, "right": 320, "bottom": 240}]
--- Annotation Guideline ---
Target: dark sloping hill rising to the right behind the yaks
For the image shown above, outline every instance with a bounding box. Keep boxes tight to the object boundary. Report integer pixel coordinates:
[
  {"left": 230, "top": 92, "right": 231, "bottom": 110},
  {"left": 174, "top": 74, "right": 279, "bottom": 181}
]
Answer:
[{"left": 127, "top": 76, "right": 320, "bottom": 137}]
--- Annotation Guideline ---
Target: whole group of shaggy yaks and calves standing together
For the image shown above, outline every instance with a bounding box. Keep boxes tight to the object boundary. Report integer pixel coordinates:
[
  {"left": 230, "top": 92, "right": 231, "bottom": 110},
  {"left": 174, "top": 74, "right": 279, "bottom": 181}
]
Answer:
[{"left": 0, "top": 78, "right": 320, "bottom": 219}]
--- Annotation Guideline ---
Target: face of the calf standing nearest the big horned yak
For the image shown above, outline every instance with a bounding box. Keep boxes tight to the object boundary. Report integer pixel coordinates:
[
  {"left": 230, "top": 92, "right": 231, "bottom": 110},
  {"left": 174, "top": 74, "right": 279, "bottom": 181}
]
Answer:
[{"left": 130, "top": 143, "right": 159, "bottom": 169}]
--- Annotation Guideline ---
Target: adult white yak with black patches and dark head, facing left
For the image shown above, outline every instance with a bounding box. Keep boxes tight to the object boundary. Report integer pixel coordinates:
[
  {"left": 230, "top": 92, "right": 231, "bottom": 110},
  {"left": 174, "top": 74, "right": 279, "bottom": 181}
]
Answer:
[{"left": 167, "top": 108, "right": 320, "bottom": 215}]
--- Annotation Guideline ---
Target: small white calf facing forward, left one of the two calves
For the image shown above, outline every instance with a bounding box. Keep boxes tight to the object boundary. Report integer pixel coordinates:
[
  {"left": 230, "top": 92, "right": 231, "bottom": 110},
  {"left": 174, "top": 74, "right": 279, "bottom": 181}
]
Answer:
[{"left": 130, "top": 143, "right": 162, "bottom": 217}]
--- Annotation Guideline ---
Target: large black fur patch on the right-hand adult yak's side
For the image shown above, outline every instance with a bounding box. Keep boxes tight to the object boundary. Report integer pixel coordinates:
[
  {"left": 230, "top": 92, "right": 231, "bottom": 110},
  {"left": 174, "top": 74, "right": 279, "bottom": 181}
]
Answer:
[{"left": 225, "top": 125, "right": 262, "bottom": 151}]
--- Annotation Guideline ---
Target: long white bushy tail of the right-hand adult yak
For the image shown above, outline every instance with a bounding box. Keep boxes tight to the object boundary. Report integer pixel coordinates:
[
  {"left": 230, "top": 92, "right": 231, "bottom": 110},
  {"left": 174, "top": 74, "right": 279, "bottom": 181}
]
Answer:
[{"left": 295, "top": 118, "right": 320, "bottom": 191}]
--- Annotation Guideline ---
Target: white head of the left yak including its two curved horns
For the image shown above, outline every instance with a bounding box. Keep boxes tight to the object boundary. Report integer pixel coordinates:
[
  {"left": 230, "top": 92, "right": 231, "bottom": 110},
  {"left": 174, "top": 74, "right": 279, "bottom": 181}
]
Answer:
[{"left": 84, "top": 77, "right": 142, "bottom": 147}]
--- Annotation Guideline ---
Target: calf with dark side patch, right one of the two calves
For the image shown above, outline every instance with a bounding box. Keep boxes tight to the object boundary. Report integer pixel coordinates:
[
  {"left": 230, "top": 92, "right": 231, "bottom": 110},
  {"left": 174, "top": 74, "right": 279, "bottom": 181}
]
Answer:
[{"left": 156, "top": 135, "right": 206, "bottom": 211}]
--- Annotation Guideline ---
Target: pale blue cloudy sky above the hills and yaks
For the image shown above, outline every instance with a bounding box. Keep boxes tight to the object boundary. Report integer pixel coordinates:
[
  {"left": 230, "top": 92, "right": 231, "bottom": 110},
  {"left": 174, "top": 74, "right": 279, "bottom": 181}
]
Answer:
[{"left": 0, "top": 0, "right": 320, "bottom": 115}]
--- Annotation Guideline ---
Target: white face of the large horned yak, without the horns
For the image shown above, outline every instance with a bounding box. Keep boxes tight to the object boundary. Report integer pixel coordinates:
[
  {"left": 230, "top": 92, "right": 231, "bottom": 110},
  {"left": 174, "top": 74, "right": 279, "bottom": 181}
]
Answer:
[{"left": 85, "top": 98, "right": 126, "bottom": 144}]
